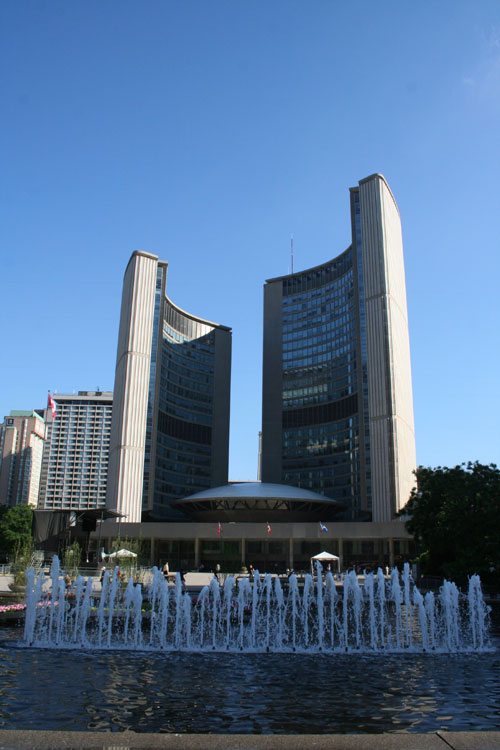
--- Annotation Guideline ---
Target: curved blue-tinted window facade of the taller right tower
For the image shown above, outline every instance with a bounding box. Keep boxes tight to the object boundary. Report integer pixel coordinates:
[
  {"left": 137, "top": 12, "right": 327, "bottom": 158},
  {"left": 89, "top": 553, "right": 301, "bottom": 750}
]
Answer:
[{"left": 282, "top": 249, "right": 361, "bottom": 514}]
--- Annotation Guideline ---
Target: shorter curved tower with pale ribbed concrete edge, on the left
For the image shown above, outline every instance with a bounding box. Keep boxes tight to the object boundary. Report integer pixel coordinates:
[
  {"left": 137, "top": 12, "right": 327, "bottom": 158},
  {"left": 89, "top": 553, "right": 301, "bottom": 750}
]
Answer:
[{"left": 106, "top": 251, "right": 231, "bottom": 522}]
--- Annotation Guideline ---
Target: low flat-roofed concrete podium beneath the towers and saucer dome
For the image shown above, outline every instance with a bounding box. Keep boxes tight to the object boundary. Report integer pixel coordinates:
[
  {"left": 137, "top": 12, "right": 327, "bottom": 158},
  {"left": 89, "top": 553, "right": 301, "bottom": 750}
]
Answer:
[{"left": 92, "top": 520, "right": 413, "bottom": 572}]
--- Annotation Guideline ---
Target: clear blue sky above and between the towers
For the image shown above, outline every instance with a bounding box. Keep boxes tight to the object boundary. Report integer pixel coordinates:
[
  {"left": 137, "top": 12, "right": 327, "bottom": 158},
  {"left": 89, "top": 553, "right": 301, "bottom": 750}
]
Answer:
[{"left": 0, "top": 0, "right": 500, "bottom": 479}]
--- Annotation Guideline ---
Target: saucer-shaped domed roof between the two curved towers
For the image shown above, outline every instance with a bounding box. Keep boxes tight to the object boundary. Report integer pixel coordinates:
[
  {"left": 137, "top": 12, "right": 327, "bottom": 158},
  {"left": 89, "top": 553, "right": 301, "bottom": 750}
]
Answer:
[{"left": 174, "top": 482, "right": 345, "bottom": 522}]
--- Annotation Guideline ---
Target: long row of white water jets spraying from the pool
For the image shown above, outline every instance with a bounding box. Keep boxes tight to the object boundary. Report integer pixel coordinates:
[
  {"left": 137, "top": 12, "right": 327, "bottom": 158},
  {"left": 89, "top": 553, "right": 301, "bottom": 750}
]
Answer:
[{"left": 18, "top": 557, "right": 489, "bottom": 653}]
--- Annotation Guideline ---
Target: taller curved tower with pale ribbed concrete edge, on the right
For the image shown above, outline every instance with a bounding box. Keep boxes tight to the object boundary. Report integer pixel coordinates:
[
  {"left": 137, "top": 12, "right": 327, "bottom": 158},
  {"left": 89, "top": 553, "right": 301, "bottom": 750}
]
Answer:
[{"left": 261, "top": 174, "right": 416, "bottom": 521}]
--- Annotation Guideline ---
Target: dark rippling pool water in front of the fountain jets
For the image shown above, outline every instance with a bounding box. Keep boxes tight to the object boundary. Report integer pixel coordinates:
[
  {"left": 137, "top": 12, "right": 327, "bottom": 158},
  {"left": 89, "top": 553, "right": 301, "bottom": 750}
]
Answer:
[{"left": 0, "top": 605, "right": 500, "bottom": 733}]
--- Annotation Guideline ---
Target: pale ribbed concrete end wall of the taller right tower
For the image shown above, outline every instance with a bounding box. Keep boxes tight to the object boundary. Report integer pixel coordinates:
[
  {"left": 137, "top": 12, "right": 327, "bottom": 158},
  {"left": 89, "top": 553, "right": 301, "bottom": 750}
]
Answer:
[{"left": 360, "top": 175, "right": 416, "bottom": 521}]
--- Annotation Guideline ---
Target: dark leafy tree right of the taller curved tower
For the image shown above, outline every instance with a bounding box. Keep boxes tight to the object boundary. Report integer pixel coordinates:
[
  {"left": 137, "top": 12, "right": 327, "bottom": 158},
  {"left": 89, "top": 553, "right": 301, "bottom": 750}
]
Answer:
[{"left": 400, "top": 461, "right": 500, "bottom": 584}]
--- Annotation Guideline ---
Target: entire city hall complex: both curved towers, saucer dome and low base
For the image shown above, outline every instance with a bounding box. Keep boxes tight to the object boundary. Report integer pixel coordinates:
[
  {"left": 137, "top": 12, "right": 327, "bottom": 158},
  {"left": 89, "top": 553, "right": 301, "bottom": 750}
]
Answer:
[{"left": 96, "top": 174, "right": 416, "bottom": 571}]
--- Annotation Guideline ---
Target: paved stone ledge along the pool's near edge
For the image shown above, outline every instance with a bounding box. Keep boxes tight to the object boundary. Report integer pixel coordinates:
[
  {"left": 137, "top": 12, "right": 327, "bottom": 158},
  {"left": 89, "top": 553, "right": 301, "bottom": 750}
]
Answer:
[{"left": 0, "top": 730, "right": 500, "bottom": 750}]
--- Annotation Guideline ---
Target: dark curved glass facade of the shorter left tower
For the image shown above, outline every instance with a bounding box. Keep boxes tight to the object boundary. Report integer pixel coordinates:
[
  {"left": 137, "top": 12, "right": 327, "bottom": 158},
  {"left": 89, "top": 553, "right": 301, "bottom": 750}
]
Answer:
[{"left": 144, "top": 296, "right": 215, "bottom": 519}]
